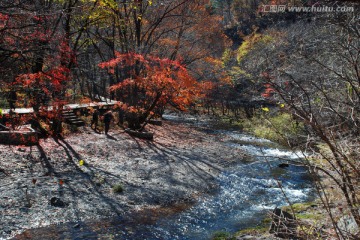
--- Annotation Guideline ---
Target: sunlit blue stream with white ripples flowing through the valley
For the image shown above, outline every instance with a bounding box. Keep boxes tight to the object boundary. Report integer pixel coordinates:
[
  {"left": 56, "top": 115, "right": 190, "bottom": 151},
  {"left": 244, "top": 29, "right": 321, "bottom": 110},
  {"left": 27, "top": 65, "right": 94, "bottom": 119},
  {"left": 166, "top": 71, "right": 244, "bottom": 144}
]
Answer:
[{"left": 12, "top": 115, "right": 313, "bottom": 240}]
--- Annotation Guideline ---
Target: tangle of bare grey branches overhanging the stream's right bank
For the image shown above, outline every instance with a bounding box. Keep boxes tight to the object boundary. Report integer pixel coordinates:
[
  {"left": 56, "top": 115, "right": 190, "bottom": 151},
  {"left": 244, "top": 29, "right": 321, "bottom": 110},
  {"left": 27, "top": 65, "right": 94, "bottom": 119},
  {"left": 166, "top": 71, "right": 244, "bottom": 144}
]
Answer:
[{"left": 242, "top": 10, "right": 360, "bottom": 239}]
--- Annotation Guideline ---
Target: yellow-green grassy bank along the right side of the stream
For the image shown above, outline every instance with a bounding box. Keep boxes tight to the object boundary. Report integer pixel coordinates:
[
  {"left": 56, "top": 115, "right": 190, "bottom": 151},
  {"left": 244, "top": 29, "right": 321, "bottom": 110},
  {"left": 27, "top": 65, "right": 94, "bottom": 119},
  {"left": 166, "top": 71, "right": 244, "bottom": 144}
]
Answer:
[{"left": 217, "top": 109, "right": 360, "bottom": 239}]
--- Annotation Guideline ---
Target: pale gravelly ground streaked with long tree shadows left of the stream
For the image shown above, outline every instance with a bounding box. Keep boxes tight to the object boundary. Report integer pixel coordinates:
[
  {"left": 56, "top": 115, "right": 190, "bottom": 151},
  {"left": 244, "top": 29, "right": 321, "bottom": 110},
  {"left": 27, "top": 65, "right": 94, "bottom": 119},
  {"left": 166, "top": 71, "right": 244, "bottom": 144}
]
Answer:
[{"left": 0, "top": 122, "right": 243, "bottom": 239}]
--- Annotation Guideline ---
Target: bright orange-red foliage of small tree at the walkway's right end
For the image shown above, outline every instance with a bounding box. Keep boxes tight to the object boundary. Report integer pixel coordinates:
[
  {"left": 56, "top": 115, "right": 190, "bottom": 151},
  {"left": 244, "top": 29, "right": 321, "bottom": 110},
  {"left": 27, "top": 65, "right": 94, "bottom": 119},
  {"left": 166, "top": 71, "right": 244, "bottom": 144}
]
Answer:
[{"left": 99, "top": 53, "right": 199, "bottom": 123}]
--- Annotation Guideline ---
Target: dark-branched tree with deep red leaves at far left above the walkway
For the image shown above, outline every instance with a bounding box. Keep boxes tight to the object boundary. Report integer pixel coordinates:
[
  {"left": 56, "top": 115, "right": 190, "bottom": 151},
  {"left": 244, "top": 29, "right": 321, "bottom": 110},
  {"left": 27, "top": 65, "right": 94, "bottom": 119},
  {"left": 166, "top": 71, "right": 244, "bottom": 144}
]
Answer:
[{"left": 0, "top": 1, "right": 75, "bottom": 111}]
